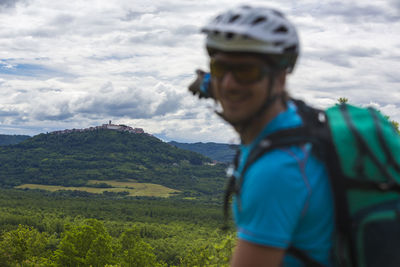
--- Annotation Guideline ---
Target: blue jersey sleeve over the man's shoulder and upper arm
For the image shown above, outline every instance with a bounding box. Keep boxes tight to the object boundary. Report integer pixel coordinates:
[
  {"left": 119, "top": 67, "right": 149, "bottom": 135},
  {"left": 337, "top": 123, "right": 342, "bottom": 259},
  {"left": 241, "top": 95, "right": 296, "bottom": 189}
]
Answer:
[{"left": 234, "top": 147, "right": 318, "bottom": 248}]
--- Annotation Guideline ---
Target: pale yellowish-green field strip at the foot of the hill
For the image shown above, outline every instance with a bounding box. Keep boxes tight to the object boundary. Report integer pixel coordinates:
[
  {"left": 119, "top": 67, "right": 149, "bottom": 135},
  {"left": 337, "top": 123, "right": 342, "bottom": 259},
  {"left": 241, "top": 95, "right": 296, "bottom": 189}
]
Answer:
[{"left": 15, "top": 180, "right": 180, "bottom": 197}]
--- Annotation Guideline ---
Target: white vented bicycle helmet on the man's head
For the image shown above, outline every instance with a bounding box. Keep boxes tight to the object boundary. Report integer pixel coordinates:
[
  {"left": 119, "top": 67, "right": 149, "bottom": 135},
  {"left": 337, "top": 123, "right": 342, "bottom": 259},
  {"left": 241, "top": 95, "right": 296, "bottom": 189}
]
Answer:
[{"left": 201, "top": 6, "right": 299, "bottom": 72}]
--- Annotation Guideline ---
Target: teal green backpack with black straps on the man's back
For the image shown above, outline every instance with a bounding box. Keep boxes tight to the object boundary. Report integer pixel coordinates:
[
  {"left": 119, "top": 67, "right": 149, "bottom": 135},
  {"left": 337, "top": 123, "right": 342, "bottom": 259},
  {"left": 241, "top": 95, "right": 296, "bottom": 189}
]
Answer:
[{"left": 224, "top": 100, "right": 400, "bottom": 267}]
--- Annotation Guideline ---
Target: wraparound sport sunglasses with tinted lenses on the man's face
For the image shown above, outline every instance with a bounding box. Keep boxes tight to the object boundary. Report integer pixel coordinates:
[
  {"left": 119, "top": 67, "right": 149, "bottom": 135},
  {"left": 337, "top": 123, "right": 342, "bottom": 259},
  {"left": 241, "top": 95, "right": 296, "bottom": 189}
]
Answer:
[{"left": 210, "top": 59, "right": 272, "bottom": 84}]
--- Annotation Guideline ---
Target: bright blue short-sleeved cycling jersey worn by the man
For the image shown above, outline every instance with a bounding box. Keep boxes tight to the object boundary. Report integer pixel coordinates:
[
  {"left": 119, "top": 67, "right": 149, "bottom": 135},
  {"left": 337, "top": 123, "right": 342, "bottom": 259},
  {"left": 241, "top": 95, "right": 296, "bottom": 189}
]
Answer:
[{"left": 233, "top": 102, "right": 334, "bottom": 267}]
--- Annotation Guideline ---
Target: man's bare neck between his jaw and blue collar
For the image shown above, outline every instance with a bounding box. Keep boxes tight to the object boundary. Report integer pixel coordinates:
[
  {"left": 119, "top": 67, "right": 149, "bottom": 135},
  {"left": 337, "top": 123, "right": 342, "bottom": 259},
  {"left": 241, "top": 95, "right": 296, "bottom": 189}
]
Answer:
[{"left": 236, "top": 101, "right": 286, "bottom": 145}]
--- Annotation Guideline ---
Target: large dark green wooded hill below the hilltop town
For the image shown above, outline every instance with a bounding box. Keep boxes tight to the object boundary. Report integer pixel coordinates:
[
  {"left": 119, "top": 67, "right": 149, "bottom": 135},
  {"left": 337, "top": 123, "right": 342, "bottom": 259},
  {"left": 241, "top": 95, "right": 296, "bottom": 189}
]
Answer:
[{"left": 0, "top": 129, "right": 226, "bottom": 195}]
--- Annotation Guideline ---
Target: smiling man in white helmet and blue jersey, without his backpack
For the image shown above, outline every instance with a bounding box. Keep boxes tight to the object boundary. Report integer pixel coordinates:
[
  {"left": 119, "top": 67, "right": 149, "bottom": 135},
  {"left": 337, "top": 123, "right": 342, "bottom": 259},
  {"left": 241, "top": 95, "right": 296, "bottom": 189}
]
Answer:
[{"left": 192, "top": 6, "right": 334, "bottom": 267}]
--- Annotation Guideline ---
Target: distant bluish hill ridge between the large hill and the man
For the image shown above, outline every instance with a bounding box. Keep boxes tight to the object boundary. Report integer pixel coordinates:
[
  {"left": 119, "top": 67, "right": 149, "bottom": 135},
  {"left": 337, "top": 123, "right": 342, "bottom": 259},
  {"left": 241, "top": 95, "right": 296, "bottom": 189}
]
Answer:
[{"left": 169, "top": 141, "right": 236, "bottom": 163}]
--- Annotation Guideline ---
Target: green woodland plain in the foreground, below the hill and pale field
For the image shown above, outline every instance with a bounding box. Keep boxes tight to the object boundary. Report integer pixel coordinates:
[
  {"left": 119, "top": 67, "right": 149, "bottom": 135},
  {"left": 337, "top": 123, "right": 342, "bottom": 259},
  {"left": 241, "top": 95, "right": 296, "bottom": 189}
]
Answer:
[{"left": 0, "top": 189, "right": 235, "bottom": 267}]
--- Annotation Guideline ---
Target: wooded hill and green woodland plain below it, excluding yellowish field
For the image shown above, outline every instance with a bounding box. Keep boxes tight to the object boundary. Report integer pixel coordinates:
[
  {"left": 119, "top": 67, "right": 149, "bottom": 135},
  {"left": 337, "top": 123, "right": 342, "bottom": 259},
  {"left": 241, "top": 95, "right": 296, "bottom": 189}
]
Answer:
[{"left": 0, "top": 129, "right": 235, "bottom": 267}]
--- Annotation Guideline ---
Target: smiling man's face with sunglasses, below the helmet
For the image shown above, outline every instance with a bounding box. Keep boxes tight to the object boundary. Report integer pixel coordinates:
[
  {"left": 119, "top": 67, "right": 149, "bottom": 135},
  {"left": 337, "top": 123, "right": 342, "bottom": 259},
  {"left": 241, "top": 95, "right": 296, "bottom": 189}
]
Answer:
[{"left": 211, "top": 53, "right": 269, "bottom": 123}]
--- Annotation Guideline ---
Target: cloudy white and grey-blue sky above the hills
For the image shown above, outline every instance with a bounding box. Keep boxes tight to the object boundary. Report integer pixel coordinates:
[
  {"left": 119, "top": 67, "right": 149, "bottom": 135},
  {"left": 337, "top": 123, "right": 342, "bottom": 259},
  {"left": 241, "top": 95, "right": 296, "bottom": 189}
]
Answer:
[{"left": 0, "top": 0, "right": 400, "bottom": 143}]
